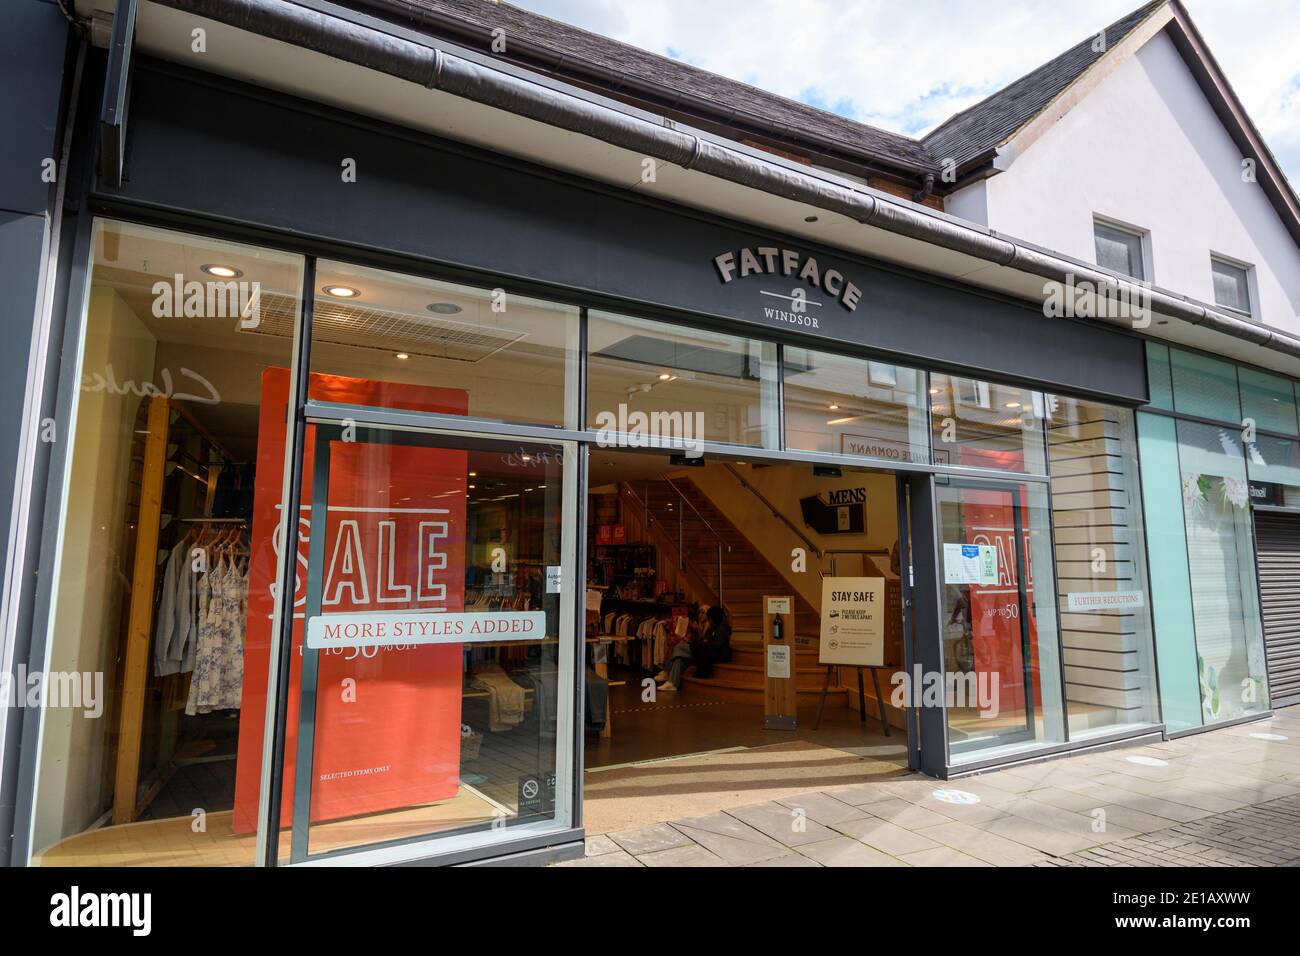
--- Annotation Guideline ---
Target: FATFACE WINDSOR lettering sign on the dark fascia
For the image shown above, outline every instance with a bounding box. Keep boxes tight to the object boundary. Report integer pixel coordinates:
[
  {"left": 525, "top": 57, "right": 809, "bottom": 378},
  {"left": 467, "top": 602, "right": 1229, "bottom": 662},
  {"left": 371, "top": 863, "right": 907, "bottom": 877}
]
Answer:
[{"left": 714, "top": 246, "right": 862, "bottom": 329}]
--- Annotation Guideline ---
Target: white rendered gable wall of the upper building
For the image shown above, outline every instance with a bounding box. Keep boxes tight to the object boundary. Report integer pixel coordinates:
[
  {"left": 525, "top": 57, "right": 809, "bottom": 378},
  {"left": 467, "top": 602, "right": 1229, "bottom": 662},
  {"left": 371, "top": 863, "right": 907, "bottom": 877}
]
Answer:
[{"left": 948, "top": 33, "right": 1300, "bottom": 332}]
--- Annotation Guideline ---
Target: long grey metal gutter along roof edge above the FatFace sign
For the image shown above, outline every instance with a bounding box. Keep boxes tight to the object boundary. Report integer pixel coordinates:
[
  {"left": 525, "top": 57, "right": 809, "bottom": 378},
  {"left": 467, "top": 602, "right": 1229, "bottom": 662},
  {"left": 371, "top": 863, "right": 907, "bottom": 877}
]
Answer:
[{"left": 153, "top": 0, "right": 1300, "bottom": 358}]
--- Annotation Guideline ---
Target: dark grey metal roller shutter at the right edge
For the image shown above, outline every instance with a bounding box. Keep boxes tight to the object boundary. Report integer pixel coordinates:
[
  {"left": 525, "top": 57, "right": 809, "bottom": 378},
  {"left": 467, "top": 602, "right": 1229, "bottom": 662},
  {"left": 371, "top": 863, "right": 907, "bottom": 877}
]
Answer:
[{"left": 1255, "top": 511, "right": 1300, "bottom": 708}]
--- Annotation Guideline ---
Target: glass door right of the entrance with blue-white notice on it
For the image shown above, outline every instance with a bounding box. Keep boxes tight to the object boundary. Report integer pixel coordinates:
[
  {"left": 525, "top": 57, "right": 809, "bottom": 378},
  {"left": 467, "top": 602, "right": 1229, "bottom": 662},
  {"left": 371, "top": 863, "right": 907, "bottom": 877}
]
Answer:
[{"left": 937, "top": 480, "right": 1063, "bottom": 765}]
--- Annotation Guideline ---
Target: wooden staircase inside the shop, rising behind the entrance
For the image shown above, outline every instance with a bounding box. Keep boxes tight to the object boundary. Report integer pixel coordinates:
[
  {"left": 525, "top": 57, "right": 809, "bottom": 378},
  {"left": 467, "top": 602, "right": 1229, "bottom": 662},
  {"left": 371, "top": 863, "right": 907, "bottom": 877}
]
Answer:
[{"left": 631, "top": 476, "right": 848, "bottom": 706}]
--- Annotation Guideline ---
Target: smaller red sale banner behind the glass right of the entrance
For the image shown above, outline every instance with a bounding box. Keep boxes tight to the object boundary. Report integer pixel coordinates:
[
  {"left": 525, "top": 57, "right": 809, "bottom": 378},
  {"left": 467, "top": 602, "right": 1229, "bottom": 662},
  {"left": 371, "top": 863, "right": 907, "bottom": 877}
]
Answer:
[{"left": 962, "top": 489, "right": 1041, "bottom": 714}]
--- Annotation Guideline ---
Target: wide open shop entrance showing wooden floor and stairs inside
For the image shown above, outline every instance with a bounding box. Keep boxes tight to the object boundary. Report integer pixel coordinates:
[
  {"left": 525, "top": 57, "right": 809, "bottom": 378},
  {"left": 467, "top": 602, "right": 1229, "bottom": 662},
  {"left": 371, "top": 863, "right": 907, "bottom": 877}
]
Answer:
[{"left": 585, "top": 449, "right": 909, "bottom": 832}]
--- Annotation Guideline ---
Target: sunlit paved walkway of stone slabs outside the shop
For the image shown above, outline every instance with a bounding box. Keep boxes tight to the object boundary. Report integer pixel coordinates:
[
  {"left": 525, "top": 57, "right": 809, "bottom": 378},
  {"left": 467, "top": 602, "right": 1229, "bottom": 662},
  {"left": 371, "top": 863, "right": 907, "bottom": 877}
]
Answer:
[{"left": 555, "top": 706, "right": 1300, "bottom": 866}]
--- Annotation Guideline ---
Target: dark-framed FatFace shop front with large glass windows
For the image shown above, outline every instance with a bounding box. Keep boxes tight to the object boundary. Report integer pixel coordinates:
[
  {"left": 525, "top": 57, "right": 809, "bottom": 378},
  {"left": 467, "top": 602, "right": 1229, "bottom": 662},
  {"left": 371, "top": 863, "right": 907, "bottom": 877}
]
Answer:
[{"left": 14, "top": 50, "right": 1170, "bottom": 865}]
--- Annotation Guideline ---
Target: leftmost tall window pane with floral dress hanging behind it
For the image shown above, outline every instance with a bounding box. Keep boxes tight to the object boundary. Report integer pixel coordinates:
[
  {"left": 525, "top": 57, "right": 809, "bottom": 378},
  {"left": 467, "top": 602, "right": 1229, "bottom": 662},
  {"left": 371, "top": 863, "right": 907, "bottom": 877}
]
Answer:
[{"left": 33, "top": 221, "right": 303, "bottom": 865}]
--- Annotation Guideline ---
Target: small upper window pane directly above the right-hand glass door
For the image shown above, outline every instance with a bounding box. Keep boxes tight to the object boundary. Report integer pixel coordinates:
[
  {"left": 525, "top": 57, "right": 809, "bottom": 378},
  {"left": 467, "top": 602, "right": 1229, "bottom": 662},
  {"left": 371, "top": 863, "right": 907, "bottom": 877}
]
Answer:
[{"left": 930, "top": 373, "right": 1047, "bottom": 475}]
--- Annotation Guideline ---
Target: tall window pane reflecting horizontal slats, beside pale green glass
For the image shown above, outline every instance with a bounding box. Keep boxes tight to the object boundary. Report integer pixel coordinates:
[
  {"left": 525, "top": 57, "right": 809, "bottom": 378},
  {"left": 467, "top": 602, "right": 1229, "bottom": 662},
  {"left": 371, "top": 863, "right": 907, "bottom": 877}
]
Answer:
[{"left": 1048, "top": 395, "right": 1157, "bottom": 740}]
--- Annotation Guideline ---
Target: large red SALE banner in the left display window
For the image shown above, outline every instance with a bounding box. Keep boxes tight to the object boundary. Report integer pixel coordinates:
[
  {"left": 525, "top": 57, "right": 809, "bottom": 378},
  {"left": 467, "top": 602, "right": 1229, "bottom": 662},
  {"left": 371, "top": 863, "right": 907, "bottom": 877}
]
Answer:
[{"left": 234, "top": 368, "right": 468, "bottom": 832}]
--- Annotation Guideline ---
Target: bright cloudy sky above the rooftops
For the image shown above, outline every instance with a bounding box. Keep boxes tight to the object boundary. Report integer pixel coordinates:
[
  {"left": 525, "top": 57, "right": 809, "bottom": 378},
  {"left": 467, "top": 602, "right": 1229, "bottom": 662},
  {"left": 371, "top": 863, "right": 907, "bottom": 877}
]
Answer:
[{"left": 511, "top": 0, "right": 1300, "bottom": 187}]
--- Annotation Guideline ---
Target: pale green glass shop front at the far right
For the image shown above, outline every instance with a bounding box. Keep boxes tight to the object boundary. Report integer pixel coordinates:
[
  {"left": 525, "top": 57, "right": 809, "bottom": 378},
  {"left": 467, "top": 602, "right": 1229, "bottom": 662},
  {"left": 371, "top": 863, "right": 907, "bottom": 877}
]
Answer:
[{"left": 1138, "top": 342, "right": 1300, "bottom": 734}]
